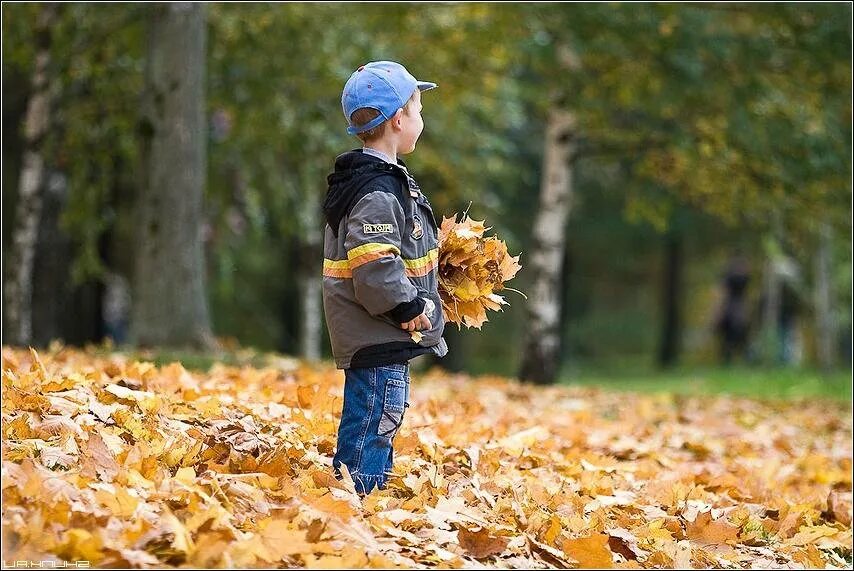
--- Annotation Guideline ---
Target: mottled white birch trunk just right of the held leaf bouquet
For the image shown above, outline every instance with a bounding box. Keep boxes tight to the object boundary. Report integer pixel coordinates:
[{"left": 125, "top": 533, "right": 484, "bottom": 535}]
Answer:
[{"left": 519, "top": 107, "right": 576, "bottom": 384}]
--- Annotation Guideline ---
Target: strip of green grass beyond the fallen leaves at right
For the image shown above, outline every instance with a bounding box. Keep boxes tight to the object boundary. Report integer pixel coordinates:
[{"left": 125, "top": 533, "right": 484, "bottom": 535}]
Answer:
[{"left": 560, "top": 366, "right": 851, "bottom": 402}]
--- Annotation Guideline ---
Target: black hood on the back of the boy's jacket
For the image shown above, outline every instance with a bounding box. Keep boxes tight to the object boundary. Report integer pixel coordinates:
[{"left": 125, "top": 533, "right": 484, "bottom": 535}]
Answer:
[{"left": 323, "top": 149, "right": 406, "bottom": 236}]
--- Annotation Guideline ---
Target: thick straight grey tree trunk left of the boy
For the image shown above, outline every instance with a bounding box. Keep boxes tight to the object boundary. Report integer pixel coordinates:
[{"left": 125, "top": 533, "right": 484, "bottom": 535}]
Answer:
[{"left": 130, "top": 3, "right": 217, "bottom": 349}]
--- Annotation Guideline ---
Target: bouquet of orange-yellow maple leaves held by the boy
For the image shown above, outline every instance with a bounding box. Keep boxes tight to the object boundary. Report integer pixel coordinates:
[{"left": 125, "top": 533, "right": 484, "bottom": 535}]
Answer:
[{"left": 438, "top": 212, "right": 524, "bottom": 329}]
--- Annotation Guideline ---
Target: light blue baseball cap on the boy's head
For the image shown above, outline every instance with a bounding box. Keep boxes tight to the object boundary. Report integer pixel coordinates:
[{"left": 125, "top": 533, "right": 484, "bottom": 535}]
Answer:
[{"left": 341, "top": 61, "right": 436, "bottom": 135}]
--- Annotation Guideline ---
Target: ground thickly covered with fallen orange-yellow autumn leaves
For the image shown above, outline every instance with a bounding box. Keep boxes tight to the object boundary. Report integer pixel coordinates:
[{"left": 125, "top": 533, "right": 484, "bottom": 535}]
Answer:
[{"left": 2, "top": 346, "right": 852, "bottom": 568}]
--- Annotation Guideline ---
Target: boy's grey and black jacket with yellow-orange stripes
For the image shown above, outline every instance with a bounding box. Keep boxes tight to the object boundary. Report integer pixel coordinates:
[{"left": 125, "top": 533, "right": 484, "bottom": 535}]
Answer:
[{"left": 323, "top": 149, "right": 448, "bottom": 369}]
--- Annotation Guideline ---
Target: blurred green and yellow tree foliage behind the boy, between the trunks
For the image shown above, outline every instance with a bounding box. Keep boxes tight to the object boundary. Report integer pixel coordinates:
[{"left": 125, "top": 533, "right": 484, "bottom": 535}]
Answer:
[{"left": 3, "top": 3, "right": 851, "bottom": 373}]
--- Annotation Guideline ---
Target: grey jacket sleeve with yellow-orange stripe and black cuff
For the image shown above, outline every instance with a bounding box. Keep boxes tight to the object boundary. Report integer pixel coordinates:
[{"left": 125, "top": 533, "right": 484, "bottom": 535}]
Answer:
[{"left": 344, "top": 191, "right": 426, "bottom": 323}]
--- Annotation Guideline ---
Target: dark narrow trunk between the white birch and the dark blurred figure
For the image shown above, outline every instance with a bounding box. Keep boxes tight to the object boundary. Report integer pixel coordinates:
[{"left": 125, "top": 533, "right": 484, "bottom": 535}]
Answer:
[{"left": 658, "top": 228, "right": 682, "bottom": 367}]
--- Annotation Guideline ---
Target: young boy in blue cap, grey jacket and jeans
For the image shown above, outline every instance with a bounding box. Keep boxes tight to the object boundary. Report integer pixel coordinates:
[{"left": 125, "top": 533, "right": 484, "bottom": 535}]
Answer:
[{"left": 323, "top": 61, "right": 448, "bottom": 494}]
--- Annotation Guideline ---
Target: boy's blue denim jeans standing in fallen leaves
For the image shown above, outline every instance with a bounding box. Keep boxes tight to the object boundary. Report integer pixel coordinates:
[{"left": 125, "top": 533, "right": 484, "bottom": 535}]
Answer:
[{"left": 332, "top": 364, "right": 409, "bottom": 495}]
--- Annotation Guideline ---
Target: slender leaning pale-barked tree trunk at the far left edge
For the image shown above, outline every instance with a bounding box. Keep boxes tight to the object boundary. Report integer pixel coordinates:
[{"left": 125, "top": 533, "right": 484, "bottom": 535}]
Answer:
[{"left": 3, "top": 4, "right": 59, "bottom": 345}]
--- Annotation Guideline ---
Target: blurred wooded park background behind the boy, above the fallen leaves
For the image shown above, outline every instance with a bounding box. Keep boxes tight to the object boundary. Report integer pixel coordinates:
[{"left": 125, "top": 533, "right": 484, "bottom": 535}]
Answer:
[{"left": 2, "top": 3, "right": 852, "bottom": 395}]
